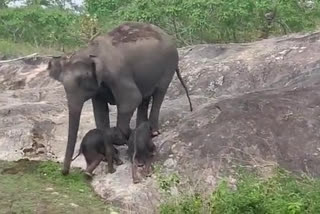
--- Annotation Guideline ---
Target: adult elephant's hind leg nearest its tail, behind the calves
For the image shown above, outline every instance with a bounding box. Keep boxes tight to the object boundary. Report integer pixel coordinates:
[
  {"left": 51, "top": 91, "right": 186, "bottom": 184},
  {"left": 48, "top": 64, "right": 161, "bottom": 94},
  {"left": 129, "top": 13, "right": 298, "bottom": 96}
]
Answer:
[{"left": 149, "top": 88, "right": 167, "bottom": 137}]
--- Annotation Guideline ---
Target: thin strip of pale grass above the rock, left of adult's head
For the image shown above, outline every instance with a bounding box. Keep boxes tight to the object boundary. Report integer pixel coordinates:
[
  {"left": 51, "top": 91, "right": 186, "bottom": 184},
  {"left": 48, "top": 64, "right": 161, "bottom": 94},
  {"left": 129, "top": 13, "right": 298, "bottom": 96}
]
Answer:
[{"left": 0, "top": 38, "right": 61, "bottom": 57}]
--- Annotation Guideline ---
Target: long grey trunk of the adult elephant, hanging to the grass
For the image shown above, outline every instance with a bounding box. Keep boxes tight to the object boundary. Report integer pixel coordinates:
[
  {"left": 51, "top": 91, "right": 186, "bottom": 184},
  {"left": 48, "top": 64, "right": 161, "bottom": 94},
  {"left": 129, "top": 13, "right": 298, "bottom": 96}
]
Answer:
[{"left": 62, "top": 96, "right": 84, "bottom": 175}]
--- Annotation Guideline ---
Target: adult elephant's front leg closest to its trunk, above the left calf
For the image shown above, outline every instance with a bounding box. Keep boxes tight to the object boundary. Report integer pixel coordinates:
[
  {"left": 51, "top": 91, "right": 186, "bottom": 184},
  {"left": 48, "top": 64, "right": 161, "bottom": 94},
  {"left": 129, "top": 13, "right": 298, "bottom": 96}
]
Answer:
[{"left": 92, "top": 95, "right": 110, "bottom": 130}]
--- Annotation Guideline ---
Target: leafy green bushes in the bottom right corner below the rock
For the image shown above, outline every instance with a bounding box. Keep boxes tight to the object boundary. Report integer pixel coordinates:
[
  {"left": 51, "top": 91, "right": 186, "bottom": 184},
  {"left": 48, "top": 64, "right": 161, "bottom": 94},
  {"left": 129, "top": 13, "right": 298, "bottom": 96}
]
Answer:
[{"left": 160, "top": 169, "right": 320, "bottom": 214}]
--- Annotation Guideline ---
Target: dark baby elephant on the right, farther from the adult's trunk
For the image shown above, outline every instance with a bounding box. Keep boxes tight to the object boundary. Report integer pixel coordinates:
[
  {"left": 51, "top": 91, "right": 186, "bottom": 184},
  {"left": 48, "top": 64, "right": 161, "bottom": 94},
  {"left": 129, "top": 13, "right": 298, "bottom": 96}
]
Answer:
[{"left": 128, "top": 121, "right": 156, "bottom": 183}]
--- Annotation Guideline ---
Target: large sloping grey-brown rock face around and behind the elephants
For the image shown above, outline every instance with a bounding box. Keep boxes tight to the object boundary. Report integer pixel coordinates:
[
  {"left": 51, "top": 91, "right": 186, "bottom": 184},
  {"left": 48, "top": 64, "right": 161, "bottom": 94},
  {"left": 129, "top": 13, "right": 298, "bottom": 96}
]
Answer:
[{"left": 0, "top": 33, "right": 320, "bottom": 213}]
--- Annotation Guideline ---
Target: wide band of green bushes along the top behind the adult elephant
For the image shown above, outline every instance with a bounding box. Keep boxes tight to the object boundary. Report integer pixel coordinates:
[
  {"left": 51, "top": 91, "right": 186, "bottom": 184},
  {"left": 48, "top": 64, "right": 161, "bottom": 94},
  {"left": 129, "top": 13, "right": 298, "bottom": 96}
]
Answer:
[{"left": 0, "top": 0, "right": 320, "bottom": 56}]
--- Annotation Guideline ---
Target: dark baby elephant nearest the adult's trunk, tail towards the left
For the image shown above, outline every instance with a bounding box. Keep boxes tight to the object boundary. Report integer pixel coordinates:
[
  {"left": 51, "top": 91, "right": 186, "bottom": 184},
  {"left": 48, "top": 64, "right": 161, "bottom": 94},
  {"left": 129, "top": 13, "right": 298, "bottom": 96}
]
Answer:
[{"left": 72, "top": 127, "right": 123, "bottom": 177}]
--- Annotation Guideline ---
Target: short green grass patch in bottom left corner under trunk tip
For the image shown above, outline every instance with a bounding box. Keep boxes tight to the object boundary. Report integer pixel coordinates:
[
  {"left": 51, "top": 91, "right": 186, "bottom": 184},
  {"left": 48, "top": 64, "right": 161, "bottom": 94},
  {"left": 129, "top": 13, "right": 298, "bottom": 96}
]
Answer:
[{"left": 0, "top": 160, "right": 114, "bottom": 214}]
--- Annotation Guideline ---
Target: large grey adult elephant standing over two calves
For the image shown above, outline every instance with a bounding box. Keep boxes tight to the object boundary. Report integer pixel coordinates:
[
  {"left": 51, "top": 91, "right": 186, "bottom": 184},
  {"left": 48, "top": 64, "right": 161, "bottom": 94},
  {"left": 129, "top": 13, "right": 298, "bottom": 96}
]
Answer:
[{"left": 48, "top": 22, "right": 192, "bottom": 175}]
